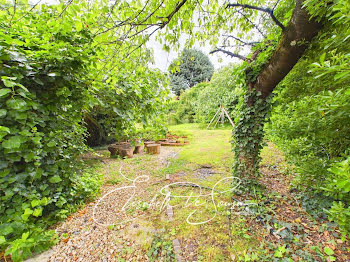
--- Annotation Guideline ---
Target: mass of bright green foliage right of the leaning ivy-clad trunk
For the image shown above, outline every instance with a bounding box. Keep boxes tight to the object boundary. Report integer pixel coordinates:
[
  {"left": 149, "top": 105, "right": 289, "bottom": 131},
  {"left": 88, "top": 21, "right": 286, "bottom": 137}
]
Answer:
[{"left": 267, "top": 1, "right": 350, "bottom": 236}]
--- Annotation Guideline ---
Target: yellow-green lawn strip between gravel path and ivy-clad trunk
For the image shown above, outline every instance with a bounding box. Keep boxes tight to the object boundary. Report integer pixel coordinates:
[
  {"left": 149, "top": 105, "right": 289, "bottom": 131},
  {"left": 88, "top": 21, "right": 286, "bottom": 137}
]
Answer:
[{"left": 157, "top": 124, "right": 256, "bottom": 261}]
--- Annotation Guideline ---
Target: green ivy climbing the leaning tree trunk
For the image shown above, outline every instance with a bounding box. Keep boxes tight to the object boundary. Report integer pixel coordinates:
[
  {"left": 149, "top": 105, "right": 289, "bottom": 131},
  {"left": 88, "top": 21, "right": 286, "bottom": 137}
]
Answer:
[{"left": 232, "top": 40, "right": 277, "bottom": 179}]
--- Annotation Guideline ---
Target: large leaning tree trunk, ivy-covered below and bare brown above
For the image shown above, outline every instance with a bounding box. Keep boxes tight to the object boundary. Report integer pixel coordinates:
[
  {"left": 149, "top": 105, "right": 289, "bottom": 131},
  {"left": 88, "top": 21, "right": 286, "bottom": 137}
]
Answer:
[{"left": 233, "top": 0, "right": 321, "bottom": 178}]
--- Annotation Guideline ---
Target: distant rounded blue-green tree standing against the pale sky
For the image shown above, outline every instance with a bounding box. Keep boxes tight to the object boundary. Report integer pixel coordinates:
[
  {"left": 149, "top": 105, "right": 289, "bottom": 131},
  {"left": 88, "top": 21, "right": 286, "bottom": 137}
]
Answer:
[{"left": 169, "top": 49, "right": 214, "bottom": 95}]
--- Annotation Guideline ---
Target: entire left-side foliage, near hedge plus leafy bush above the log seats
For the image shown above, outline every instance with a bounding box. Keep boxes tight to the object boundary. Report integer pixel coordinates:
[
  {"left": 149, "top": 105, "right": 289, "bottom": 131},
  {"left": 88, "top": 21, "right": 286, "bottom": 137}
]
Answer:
[{"left": 0, "top": 2, "right": 167, "bottom": 261}]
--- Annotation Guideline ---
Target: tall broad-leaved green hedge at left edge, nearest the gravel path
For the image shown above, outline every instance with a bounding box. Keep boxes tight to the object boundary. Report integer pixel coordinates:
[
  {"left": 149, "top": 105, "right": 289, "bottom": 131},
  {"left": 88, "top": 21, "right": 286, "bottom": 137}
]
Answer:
[{"left": 0, "top": 7, "right": 98, "bottom": 260}]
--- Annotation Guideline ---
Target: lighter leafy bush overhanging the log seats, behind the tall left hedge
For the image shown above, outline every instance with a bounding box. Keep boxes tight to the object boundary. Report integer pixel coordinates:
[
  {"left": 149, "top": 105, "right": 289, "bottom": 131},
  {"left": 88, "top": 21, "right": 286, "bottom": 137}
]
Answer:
[{"left": 84, "top": 62, "right": 169, "bottom": 146}]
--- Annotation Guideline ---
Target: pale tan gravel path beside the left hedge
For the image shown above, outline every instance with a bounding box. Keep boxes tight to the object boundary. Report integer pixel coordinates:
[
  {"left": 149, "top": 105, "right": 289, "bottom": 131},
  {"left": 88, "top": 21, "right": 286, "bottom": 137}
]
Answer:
[{"left": 27, "top": 147, "right": 178, "bottom": 262}]
